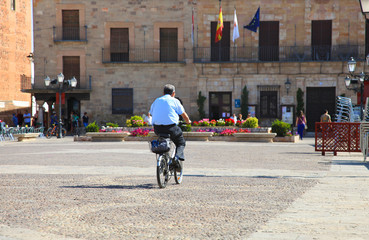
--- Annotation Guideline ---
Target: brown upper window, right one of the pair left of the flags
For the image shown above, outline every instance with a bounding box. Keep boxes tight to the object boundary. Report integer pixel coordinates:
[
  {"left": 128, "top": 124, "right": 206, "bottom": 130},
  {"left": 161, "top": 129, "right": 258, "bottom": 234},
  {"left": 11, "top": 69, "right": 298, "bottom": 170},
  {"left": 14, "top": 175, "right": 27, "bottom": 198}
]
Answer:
[{"left": 160, "top": 28, "right": 178, "bottom": 62}]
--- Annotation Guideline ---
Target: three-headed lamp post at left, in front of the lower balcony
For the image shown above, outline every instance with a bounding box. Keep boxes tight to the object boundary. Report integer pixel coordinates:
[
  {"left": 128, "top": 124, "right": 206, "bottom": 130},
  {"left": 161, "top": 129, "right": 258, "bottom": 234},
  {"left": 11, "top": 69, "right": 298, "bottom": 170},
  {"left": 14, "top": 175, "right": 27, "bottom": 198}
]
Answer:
[{"left": 44, "top": 73, "right": 77, "bottom": 138}]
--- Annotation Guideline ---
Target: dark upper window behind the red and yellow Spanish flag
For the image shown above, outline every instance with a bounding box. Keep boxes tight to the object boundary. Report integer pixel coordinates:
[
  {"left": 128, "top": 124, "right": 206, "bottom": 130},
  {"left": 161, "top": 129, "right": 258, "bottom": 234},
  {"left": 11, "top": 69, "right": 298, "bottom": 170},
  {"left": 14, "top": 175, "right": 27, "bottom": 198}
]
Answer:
[{"left": 210, "top": 22, "right": 231, "bottom": 62}]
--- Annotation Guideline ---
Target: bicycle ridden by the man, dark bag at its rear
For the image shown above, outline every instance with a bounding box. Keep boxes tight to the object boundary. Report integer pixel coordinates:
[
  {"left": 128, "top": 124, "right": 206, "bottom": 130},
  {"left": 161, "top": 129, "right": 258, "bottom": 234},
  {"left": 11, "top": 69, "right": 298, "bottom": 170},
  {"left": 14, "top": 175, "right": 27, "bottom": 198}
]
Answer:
[{"left": 150, "top": 134, "right": 183, "bottom": 188}]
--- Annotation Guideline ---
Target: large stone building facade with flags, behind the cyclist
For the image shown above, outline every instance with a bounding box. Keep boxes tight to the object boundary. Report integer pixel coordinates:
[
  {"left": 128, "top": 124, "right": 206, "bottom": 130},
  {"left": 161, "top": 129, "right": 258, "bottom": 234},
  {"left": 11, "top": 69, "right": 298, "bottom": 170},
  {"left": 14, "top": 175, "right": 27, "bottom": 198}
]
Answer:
[{"left": 28, "top": 0, "right": 369, "bottom": 129}]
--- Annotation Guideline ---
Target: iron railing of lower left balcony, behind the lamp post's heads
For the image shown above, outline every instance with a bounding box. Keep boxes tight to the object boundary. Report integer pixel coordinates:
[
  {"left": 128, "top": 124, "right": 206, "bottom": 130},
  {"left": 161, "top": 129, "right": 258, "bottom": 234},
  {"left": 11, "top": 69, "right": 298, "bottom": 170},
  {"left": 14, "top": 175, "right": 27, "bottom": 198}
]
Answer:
[{"left": 20, "top": 75, "right": 92, "bottom": 90}]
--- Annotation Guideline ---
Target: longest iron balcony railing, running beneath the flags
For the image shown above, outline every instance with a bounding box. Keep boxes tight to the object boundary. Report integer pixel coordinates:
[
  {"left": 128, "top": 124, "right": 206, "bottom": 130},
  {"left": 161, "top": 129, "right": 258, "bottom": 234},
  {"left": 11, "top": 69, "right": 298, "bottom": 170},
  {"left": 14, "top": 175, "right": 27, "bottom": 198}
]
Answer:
[{"left": 193, "top": 45, "right": 366, "bottom": 63}]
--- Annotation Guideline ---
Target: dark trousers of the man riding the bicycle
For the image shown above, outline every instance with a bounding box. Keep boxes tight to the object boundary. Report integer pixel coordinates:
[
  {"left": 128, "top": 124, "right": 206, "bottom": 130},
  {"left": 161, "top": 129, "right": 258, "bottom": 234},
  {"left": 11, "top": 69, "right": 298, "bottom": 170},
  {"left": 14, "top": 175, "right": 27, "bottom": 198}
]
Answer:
[{"left": 154, "top": 124, "right": 186, "bottom": 161}]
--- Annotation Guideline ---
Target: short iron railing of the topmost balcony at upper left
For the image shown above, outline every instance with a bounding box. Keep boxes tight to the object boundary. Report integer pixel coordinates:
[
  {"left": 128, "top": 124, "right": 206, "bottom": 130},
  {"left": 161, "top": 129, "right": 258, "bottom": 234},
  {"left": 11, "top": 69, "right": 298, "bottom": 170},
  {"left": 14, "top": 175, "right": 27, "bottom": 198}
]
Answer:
[{"left": 53, "top": 26, "right": 87, "bottom": 42}]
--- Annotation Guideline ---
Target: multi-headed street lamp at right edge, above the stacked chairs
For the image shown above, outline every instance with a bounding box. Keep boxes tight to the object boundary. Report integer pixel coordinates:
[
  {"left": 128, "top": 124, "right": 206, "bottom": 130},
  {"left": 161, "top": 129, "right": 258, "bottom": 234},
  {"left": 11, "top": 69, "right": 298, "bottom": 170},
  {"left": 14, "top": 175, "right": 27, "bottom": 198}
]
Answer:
[{"left": 345, "top": 56, "right": 369, "bottom": 120}]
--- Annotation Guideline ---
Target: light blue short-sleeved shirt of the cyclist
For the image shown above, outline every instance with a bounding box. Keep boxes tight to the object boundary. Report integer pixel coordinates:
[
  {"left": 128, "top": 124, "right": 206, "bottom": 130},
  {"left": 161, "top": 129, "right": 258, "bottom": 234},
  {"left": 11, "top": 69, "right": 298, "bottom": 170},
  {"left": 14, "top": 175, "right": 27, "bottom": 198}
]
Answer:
[{"left": 150, "top": 94, "right": 185, "bottom": 125}]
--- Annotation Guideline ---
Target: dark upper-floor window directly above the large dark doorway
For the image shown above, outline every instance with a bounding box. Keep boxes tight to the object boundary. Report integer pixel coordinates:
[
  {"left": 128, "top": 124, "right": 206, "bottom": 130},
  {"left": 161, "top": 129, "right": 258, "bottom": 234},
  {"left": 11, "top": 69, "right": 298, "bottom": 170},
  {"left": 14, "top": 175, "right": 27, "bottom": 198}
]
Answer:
[{"left": 311, "top": 20, "right": 332, "bottom": 61}]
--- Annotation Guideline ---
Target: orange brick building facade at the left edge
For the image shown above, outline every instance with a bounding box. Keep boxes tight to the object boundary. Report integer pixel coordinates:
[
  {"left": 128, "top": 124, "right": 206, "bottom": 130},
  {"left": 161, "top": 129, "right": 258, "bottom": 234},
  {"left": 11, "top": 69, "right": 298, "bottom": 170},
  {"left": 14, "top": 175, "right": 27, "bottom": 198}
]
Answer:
[{"left": 0, "top": 0, "right": 32, "bottom": 125}]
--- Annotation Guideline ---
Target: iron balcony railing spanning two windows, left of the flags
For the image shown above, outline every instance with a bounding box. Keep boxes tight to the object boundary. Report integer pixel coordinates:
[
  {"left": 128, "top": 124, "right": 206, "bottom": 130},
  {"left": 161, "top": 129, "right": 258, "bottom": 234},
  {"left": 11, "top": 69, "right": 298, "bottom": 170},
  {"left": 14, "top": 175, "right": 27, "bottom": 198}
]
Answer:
[{"left": 102, "top": 47, "right": 186, "bottom": 63}]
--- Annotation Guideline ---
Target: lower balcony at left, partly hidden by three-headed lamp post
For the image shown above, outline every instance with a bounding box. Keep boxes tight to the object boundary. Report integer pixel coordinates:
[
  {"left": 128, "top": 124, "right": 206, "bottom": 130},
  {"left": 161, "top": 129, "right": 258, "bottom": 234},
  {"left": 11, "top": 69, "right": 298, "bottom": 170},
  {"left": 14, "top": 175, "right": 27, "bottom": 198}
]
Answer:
[{"left": 20, "top": 75, "right": 92, "bottom": 93}]
